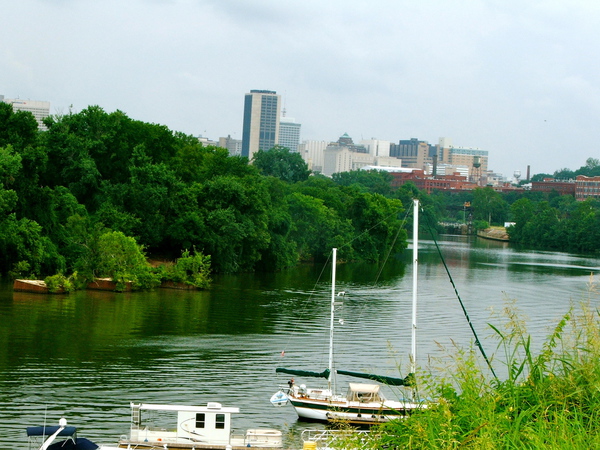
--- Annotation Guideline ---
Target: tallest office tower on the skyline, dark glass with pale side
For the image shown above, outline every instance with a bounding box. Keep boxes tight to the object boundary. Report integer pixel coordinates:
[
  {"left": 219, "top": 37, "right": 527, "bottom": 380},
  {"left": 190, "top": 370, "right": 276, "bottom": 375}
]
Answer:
[{"left": 242, "top": 90, "right": 281, "bottom": 159}]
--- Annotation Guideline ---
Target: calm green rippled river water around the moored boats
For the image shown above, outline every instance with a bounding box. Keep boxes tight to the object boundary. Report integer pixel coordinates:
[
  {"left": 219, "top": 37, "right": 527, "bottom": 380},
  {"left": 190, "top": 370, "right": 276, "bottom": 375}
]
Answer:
[{"left": 0, "top": 236, "right": 600, "bottom": 449}]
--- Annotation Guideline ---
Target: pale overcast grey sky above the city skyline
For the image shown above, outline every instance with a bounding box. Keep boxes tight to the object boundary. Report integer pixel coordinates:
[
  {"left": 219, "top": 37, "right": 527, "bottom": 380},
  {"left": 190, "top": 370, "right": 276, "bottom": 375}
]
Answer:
[{"left": 0, "top": 0, "right": 600, "bottom": 177}]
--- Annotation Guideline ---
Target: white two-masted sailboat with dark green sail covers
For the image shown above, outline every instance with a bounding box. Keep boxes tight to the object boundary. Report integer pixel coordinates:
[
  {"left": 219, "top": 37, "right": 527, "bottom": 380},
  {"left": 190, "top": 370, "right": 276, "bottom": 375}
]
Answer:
[{"left": 271, "top": 199, "right": 427, "bottom": 425}]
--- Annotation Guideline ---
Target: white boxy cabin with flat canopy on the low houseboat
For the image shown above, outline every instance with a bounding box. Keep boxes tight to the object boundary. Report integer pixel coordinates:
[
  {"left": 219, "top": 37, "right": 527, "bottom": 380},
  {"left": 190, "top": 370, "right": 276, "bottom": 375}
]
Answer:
[{"left": 130, "top": 402, "right": 240, "bottom": 444}]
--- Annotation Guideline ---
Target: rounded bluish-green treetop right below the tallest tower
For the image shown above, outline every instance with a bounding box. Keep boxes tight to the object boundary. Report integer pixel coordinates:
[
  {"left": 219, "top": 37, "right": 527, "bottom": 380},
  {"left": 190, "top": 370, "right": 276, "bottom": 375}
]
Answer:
[{"left": 252, "top": 146, "right": 310, "bottom": 183}]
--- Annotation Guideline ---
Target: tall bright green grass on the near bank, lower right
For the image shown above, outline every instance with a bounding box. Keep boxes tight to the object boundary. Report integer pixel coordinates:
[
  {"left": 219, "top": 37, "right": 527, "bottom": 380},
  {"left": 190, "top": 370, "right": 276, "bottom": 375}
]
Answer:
[{"left": 360, "top": 284, "right": 600, "bottom": 450}]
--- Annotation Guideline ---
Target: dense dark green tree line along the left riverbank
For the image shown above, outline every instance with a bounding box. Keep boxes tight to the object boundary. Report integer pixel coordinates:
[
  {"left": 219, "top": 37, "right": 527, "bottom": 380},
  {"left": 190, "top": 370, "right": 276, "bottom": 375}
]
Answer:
[{"left": 0, "top": 103, "right": 406, "bottom": 286}]
